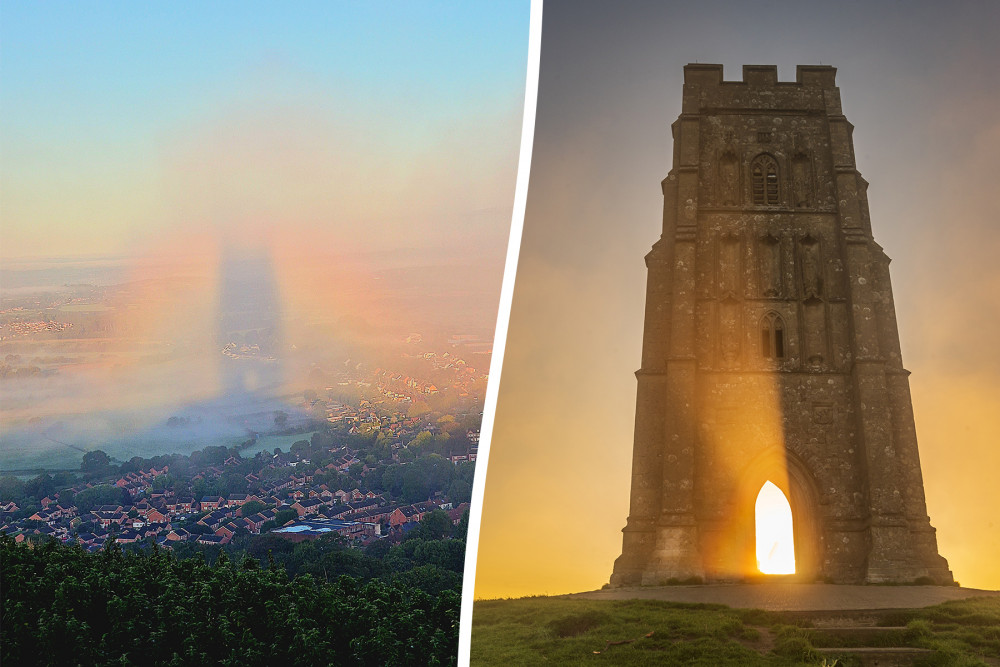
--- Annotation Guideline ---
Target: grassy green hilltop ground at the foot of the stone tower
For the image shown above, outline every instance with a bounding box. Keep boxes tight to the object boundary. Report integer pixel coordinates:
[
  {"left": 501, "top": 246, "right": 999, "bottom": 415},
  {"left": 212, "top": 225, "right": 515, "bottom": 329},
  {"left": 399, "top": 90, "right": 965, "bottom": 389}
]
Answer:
[{"left": 472, "top": 597, "right": 1000, "bottom": 667}]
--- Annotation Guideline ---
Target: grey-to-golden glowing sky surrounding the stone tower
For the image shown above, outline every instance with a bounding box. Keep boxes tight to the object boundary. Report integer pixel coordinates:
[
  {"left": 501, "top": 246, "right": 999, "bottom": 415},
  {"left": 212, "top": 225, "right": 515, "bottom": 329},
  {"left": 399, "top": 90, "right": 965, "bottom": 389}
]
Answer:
[{"left": 476, "top": 0, "right": 1000, "bottom": 597}]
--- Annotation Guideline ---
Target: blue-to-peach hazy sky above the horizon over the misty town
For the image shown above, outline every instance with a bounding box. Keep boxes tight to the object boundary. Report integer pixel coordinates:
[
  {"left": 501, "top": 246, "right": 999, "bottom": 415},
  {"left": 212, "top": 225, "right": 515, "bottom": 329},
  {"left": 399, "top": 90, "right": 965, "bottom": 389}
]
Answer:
[{"left": 0, "top": 0, "right": 528, "bottom": 262}]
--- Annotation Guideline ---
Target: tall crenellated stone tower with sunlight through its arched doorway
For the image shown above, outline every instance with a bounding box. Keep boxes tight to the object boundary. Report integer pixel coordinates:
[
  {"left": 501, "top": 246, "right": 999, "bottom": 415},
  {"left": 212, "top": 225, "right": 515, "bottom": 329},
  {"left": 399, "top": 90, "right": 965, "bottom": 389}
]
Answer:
[{"left": 611, "top": 64, "right": 952, "bottom": 586}]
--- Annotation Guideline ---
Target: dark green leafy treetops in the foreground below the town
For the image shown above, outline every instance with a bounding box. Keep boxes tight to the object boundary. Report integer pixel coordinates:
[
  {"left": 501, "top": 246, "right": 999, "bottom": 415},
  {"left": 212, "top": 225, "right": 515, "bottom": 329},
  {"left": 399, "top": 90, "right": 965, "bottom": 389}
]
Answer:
[{"left": 0, "top": 535, "right": 460, "bottom": 666}]
